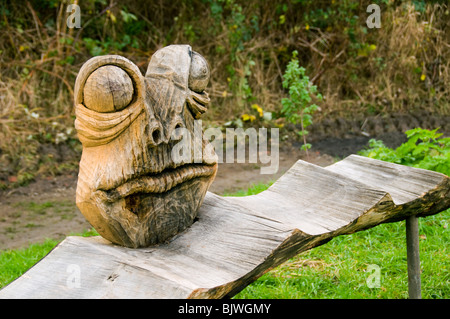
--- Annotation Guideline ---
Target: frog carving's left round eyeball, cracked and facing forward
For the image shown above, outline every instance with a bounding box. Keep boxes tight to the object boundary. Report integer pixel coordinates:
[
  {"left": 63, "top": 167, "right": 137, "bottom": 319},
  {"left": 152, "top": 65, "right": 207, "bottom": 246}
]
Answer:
[{"left": 83, "top": 65, "right": 134, "bottom": 113}]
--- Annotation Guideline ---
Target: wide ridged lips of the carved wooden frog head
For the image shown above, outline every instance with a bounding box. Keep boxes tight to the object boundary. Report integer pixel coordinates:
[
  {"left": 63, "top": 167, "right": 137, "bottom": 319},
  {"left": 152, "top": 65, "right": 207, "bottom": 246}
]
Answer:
[{"left": 95, "top": 163, "right": 217, "bottom": 203}]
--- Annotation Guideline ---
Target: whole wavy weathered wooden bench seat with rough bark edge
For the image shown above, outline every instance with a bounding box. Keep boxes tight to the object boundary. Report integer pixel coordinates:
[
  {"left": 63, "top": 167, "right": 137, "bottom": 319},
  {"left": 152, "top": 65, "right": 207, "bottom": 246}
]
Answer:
[{"left": 0, "top": 156, "right": 450, "bottom": 298}]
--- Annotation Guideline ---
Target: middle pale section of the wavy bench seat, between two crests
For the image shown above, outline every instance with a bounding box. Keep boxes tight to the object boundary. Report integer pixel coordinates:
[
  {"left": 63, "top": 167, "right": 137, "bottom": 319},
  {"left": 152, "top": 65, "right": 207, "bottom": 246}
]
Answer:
[{"left": 230, "top": 161, "right": 392, "bottom": 235}]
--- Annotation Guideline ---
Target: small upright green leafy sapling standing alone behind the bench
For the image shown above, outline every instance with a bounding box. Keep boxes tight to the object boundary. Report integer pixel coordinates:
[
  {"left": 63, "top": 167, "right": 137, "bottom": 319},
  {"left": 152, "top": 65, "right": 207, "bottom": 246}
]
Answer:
[{"left": 281, "top": 51, "right": 322, "bottom": 153}]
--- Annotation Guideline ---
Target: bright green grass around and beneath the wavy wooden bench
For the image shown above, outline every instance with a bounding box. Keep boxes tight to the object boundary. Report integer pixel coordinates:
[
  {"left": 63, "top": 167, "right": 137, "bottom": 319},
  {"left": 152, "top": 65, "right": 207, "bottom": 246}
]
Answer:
[{"left": 0, "top": 182, "right": 450, "bottom": 299}]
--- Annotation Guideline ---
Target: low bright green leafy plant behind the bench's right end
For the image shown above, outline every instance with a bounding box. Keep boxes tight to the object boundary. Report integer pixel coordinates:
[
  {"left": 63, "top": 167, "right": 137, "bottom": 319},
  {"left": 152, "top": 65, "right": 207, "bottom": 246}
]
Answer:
[{"left": 360, "top": 128, "right": 450, "bottom": 176}]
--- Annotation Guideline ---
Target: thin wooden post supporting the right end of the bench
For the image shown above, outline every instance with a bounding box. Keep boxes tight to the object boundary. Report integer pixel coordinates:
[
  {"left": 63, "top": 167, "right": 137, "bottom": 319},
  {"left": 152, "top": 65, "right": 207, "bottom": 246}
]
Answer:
[{"left": 406, "top": 216, "right": 422, "bottom": 299}]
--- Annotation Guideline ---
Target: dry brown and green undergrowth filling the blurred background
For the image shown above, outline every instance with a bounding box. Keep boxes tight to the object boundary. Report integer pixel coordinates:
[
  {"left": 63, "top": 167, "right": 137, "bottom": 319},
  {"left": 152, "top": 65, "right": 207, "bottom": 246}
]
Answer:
[{"left": 0, "top": 0, "right": 450, "bottom": 188}]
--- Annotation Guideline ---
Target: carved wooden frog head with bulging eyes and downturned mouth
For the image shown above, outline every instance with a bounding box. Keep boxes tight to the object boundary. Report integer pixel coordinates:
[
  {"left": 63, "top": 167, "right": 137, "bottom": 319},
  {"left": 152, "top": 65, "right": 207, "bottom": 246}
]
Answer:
[{"left": 74, "top": 45, "right": 217, "bottom": 248}]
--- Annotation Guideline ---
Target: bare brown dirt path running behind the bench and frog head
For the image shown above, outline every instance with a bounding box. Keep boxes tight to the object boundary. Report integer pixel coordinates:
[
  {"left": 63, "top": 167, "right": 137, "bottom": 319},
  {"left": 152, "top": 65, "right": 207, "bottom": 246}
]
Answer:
[{"left": 0, "top": 114, "right": 442, "bottom": 251}]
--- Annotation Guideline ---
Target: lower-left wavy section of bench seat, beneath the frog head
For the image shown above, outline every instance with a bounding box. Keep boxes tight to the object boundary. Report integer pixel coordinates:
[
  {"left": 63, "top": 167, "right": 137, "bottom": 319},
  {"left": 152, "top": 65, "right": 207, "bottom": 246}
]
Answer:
[{"left": 0, "top": 193, "right": 291, "bottom": 298}]
